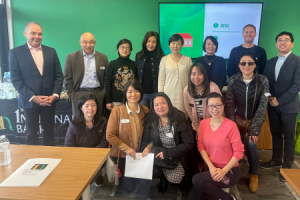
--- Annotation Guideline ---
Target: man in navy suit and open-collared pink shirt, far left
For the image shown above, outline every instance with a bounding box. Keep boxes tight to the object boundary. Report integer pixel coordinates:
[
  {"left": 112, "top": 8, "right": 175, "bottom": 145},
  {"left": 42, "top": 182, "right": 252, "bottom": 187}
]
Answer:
[{"left": 9, "top": 22, "right": 63, "bottom": 146}]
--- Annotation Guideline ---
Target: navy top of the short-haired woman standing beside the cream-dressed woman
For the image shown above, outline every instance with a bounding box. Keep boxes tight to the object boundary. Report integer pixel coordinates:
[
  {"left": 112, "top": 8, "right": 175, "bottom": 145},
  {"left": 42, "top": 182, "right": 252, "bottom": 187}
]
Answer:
[{"left": 196, "top": 56, "right": 226, "bottom": 91}]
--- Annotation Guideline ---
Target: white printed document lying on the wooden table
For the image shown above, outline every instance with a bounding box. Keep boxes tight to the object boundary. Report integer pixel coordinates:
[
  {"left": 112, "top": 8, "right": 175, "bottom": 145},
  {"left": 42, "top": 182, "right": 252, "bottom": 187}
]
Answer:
[{"left": 0, "top": 158, "right": 61, "bottom": 187}]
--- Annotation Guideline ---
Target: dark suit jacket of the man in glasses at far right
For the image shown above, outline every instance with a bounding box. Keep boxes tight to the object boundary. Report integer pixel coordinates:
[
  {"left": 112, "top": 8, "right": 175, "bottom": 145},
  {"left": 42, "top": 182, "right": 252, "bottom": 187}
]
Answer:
[{"left": 264, "top": 53, "right": 300, "bottom": 113}]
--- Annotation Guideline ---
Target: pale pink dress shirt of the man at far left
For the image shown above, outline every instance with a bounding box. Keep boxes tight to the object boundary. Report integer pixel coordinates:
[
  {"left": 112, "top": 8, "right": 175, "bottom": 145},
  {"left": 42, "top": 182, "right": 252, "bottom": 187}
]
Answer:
[{"left": 27, "top": 42, "right": 59, "bottom": 102}]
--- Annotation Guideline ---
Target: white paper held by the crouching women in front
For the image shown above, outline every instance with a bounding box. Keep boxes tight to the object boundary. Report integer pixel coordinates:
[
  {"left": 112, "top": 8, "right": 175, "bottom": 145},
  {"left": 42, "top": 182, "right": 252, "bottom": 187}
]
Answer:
[{"left": 124, "top": 153, "right": 154, "bottom": 180}]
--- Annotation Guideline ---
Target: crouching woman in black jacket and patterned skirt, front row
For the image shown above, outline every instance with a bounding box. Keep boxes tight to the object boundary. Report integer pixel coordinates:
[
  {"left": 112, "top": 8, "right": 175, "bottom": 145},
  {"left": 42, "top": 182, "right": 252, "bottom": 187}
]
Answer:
[{"left": 141, "top": 92, "right": 194, "bottom": 193}]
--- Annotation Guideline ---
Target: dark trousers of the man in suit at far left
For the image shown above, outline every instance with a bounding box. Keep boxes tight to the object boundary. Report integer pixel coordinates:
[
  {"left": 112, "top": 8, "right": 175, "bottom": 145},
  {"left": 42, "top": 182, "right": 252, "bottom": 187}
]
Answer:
[{"left": 24, "top": 103, "right": 55, "bottom": 146}]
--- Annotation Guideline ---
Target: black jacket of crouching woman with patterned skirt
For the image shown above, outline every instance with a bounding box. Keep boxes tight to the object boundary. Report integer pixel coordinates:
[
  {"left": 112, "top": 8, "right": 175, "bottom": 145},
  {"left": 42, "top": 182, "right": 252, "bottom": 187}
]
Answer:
[{"left": 141, "top": 119, "right": 194, "bottom": 165}]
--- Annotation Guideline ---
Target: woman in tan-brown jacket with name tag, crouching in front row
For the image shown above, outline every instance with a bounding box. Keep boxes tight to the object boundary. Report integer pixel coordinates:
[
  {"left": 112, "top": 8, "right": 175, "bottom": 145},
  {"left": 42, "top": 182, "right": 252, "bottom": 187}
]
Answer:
[{"left": 106, "top": 79, "right": 149, "bottom": 192}]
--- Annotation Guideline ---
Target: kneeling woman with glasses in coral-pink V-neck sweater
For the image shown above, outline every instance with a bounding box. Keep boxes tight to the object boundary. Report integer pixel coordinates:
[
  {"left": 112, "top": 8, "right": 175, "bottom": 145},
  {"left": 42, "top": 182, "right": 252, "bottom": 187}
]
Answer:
[{"left": 187, "top": 92, "right": 244, "bottom": 200}]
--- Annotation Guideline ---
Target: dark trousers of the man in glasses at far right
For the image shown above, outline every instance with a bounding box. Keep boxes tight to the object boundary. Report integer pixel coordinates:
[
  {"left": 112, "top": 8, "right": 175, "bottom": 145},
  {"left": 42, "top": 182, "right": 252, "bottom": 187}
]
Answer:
[{"left": 268, "top": 107, "right": 298, "bottom": 168}]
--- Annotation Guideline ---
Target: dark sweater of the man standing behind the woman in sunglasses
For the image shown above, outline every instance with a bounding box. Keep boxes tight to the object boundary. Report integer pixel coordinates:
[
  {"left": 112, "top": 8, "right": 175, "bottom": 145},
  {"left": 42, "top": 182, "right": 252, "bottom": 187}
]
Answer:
[{"left": 227, "top": 45, "right": 267, "bottom": 78}]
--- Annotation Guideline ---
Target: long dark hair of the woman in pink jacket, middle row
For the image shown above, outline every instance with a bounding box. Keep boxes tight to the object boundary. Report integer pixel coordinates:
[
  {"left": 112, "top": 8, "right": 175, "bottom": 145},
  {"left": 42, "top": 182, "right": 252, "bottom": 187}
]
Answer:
[{"left": 188, "top": 63, "right": 210, "bottom": 98}]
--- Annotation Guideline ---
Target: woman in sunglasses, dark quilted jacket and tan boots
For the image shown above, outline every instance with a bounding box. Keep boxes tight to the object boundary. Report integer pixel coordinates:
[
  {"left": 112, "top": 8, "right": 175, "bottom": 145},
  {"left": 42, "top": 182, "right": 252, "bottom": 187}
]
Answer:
[{"left": 225, "top": 53, "right": 269, "bottom": 192}]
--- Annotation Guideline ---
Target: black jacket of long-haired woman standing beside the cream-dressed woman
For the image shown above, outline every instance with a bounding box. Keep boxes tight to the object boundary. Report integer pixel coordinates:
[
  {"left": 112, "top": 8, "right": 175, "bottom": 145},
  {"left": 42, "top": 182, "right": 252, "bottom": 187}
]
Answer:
[{"left": 135, "top": 53, "right": 161, "bottom": 93}]
